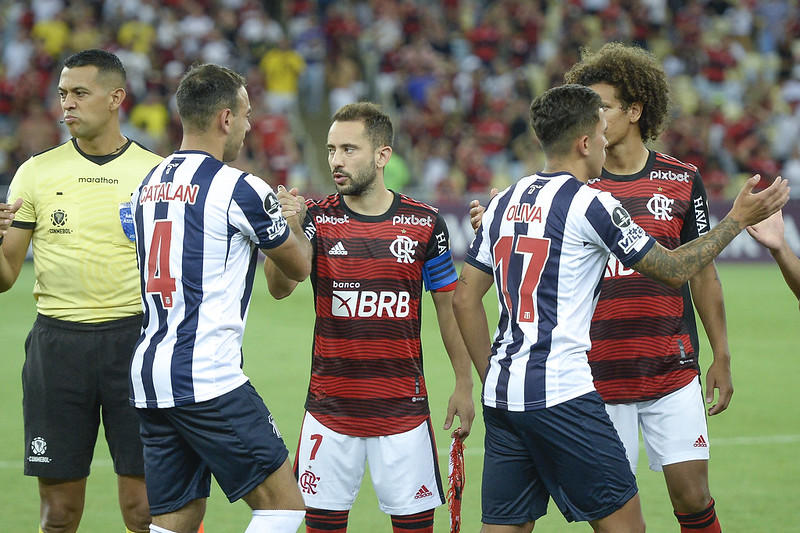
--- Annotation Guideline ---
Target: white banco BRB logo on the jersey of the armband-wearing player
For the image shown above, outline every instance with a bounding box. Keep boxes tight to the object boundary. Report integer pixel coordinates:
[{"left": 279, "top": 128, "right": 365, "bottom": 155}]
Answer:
[{"left": 331, "top": 281, "right": 411, "bottom": 318}]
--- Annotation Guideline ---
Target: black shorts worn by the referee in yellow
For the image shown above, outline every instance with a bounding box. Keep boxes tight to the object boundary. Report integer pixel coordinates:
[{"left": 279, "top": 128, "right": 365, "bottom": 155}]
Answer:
[{"left": 22, "top": 315, "right": 144, "bottom": 479}]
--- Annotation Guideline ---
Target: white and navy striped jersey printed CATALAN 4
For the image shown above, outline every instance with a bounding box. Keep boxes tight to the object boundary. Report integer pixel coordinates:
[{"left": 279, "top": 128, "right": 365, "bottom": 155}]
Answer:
[{"left": 131, "top": 151, "right": 289, "bottom": 408}]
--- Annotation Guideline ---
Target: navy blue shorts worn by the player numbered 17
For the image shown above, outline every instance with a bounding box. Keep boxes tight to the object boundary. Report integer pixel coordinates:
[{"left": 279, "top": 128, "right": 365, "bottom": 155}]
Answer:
[{"left": 481, "top": 392, "right": 638, "bottom": 525}]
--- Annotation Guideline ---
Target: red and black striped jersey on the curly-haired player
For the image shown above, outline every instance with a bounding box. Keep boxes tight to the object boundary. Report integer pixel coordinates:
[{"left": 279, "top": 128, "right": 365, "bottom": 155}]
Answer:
[{"left": 589, "top": 151, "right": 709, "bottom": 403}]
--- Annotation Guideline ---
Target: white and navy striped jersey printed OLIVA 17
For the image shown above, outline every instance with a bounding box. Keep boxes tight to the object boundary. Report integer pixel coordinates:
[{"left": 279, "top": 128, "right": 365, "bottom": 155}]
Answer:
[{"left": 466, "top": 173, "right": 655, "bottom": 411}]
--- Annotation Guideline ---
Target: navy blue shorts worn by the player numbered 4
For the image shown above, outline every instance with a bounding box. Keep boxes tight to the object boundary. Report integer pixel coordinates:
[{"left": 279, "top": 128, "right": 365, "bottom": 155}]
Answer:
[{"left": 136, "top": 382, "right": 289, "bottom": 515}]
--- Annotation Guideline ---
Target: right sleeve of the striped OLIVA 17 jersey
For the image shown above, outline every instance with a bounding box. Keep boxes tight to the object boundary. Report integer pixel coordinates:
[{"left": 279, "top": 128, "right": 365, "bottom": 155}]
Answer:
[{"left": 586, "top": 192, "right": 656, "bottom": 268}]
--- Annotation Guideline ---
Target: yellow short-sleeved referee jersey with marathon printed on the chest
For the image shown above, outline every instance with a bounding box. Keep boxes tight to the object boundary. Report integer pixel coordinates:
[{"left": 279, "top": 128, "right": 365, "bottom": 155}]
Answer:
[{"left": 8, "top": 139, "right": 162, "bottom": 322}]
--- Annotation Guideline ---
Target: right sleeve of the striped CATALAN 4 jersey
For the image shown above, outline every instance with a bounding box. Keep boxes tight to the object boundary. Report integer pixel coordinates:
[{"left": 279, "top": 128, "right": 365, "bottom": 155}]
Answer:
[{"left": 229, "top": 174, "right": 290, "bottom": 250}]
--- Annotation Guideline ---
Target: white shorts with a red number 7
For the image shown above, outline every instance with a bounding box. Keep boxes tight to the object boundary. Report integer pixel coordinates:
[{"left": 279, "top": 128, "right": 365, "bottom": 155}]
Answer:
[{"left": 295, "top": 413, "right": 445, "bottom": 516}]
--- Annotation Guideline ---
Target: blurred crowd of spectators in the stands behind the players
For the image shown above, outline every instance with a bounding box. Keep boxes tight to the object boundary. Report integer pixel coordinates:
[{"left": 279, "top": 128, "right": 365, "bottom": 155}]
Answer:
[{"left": 0, "top": 0, "right": 800, "bottom": 201}]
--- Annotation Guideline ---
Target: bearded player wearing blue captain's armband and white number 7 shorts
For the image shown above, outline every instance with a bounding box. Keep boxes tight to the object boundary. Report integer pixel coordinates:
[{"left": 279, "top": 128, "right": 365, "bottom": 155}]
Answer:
[{"left": 266, "top": 102, "right": 475, "bottom": 533}]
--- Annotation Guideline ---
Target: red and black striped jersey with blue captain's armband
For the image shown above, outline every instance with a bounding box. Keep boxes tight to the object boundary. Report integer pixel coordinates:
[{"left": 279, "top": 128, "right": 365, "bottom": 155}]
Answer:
[{"left": 305, "top": 194, "right": 457, "bottom": 437}]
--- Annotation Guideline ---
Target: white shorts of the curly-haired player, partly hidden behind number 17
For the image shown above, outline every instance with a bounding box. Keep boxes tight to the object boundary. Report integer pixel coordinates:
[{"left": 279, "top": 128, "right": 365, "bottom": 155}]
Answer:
[{"left": 606, "top": 378, "right": 711, "bottom": 474}]
